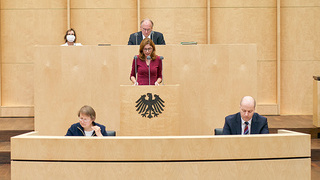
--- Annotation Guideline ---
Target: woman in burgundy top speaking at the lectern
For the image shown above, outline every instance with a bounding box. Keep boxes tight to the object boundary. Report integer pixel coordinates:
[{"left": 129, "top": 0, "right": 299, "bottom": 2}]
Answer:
[{"left": 130, "top": 38, "right": 162, "bottom": 86}]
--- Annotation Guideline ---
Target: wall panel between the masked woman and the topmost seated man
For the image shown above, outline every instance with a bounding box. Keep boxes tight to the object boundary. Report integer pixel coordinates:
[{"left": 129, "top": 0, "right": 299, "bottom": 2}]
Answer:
[{"left": 71, "top": 0, "right": 137, "bottom": 45}]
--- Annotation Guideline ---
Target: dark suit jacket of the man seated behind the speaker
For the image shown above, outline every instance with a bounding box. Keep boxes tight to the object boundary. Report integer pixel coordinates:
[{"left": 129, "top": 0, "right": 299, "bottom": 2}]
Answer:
[{"left": 128, "top": 31, "right": 166, "bottom": 45}]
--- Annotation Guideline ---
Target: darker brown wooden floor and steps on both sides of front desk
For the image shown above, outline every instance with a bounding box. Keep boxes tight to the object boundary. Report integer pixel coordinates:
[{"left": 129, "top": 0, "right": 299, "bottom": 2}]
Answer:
[{"left": 0, "top": 115, "right": 320, "bottom": 179}]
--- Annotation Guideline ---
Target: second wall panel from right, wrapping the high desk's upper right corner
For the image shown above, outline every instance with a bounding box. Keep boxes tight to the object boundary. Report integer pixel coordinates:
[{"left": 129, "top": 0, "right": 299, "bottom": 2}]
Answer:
[{"left": 210, "top": 1, "right": 277, "bottom": 104}]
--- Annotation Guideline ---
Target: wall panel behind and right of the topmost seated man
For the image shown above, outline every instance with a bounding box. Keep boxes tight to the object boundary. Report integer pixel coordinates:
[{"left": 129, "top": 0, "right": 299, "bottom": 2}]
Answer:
[{"left": 141, "top": 0, "right": 207, "bottom": 44}]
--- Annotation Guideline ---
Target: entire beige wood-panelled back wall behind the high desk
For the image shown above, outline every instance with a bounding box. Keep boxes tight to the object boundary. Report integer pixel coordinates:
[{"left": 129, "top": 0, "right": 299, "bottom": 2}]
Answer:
[{"left": 0, "top": 0, "right": 320, "bottom": 116}]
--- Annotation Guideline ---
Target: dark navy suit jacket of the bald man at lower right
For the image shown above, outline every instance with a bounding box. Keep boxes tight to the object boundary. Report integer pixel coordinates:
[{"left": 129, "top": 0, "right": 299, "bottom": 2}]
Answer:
[{"left": 223, "top": 112, "right": 269, "bottom": 135}]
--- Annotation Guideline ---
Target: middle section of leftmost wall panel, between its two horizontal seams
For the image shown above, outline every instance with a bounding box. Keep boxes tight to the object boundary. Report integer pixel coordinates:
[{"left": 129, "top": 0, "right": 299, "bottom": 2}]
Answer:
[{"left": 1, "top": 9, "right": 66, "bottom": 63}]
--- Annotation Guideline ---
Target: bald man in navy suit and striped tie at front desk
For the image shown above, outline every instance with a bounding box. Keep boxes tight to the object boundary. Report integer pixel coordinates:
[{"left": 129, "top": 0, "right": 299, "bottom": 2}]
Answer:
[{"left": 223, "top": 96, "right": 269, "bottom": 135}]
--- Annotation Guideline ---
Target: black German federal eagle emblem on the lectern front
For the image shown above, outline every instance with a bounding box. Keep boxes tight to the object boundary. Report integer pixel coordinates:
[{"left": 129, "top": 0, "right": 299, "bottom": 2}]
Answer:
[{"left": 136, "top": 93, "right": 164, "bottom": 119}]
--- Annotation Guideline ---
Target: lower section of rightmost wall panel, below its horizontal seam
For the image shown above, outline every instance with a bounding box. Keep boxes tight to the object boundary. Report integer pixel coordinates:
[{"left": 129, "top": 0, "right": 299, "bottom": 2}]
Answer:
[{"left": 280, "top": 61, "right": 320, "bottom": 115}]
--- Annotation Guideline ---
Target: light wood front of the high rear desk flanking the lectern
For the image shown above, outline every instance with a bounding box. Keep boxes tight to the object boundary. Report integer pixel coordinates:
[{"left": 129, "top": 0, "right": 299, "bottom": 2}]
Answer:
[{"left": 35, "top": 45, "right": 257, "bottom": 135}]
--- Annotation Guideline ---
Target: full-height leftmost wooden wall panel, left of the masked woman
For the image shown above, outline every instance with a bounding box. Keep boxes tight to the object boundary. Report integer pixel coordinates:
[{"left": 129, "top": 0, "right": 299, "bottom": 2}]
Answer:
[{"left": 1, "top": 0, "right": 66, "bottom": 108}]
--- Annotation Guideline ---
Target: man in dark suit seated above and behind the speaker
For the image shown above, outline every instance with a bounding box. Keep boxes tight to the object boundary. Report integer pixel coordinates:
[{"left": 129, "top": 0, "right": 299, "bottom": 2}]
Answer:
[{"left": 128, "top": 19, "right": 166, "bottom": 45}]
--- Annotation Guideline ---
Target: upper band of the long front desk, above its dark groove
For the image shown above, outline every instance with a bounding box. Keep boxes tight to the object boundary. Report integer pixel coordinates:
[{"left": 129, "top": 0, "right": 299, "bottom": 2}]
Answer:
[{"left": 11, "top": 131, "right": 311, "bottom": 162}]
